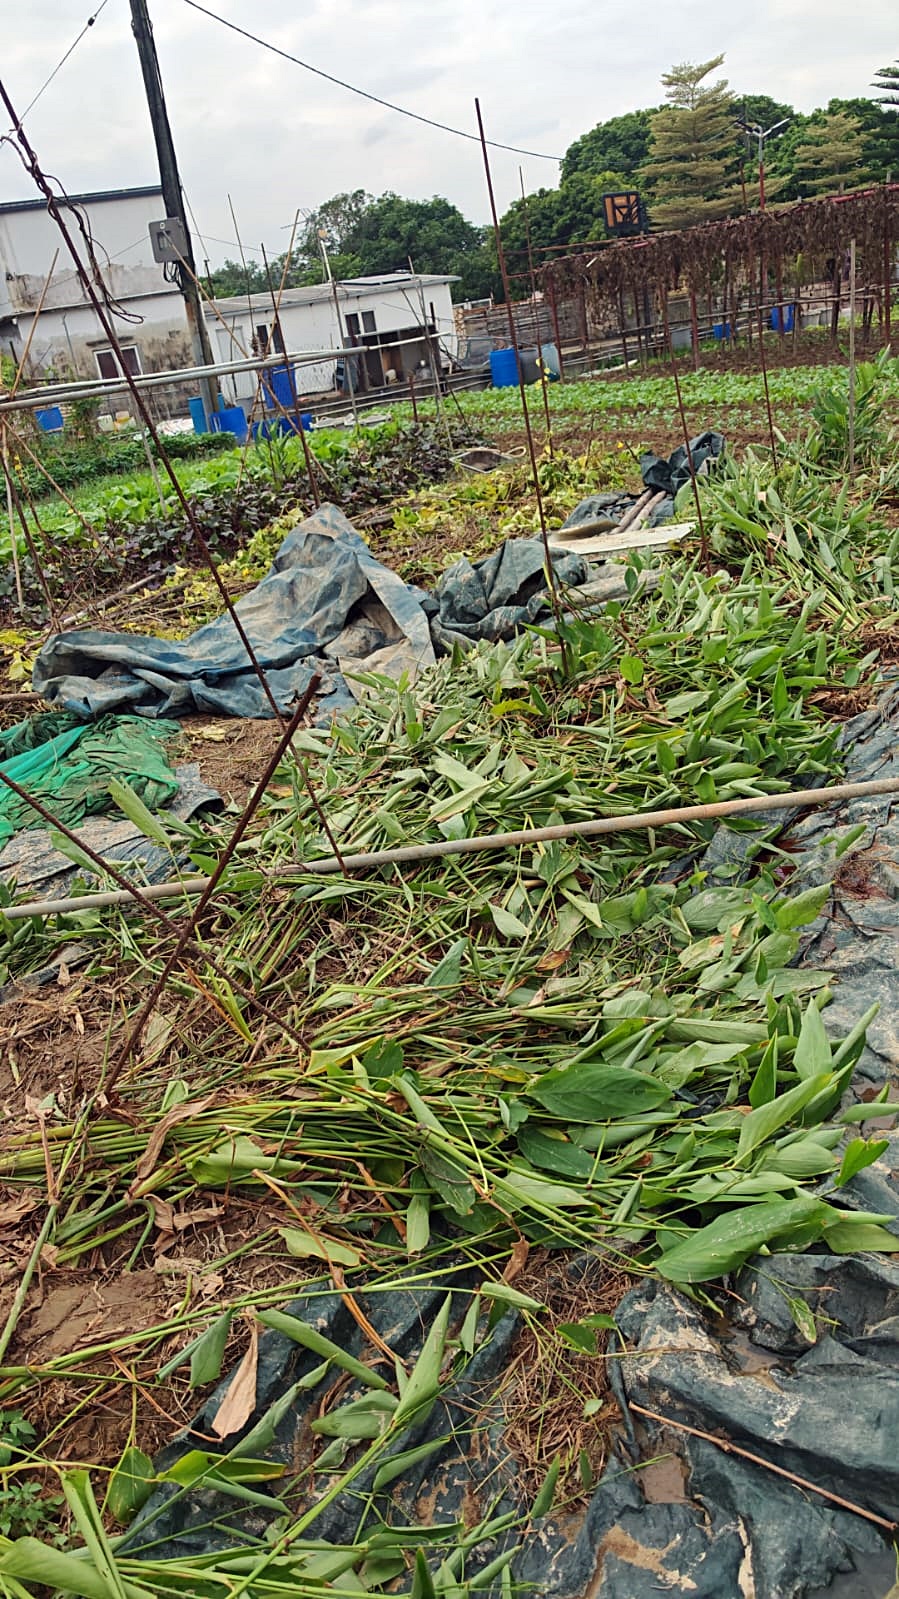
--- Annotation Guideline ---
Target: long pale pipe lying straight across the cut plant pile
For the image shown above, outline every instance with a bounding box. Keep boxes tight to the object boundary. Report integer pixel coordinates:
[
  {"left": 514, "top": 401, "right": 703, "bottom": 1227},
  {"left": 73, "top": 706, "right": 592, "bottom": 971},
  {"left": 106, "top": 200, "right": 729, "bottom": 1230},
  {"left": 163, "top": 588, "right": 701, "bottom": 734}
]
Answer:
[{"left": 8, "top": 777, "right": 899, "bottom": 921}]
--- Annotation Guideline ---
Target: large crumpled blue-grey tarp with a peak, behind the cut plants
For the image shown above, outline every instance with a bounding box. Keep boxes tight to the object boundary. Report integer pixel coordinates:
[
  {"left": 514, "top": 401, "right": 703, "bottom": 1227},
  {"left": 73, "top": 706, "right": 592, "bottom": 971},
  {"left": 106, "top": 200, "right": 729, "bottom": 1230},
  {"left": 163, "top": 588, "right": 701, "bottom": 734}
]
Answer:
[{"left": 34, "top": 505, "right": 587, "bottom": 720}]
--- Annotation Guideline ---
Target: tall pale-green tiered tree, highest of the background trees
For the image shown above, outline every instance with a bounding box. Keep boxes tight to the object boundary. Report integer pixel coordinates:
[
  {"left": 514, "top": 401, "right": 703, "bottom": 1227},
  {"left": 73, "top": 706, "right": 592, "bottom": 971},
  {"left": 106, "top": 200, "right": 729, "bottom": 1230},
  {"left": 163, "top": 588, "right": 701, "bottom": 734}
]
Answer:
[{"left": 641, "top": 56, "right": 737, "bottom": 227}]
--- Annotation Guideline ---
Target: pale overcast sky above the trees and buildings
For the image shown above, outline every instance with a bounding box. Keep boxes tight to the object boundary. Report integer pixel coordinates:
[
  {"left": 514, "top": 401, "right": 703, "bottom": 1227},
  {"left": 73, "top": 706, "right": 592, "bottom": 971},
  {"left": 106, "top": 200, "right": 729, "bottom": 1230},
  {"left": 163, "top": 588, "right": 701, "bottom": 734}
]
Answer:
[{"left": 0, "top": 0, "right": 899, "bottom": 262}]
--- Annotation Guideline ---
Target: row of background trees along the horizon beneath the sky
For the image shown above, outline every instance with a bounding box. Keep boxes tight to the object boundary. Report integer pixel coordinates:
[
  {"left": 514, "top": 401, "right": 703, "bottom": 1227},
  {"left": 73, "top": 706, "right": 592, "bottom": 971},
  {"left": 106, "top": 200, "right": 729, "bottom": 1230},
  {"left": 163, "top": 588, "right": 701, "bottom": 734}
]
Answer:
[{"left": 210, "top": 56, "right": 899, "bottom": 301}]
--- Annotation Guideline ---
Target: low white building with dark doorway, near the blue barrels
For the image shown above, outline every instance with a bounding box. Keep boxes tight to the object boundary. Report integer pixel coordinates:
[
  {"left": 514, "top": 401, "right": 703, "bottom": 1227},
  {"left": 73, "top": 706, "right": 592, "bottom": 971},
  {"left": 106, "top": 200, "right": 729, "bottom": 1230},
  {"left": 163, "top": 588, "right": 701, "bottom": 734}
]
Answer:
[{"left": 205, "top": 272, "right": 457, "bottom": 409}]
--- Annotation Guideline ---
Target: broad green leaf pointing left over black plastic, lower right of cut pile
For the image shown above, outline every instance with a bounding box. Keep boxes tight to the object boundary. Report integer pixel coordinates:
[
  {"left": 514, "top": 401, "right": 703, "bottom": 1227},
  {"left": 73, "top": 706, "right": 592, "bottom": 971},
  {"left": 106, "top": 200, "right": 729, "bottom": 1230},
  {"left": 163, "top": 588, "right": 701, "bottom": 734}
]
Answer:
[{"left": 656, "top": 1194, "right": 825, "bottom": 1282}]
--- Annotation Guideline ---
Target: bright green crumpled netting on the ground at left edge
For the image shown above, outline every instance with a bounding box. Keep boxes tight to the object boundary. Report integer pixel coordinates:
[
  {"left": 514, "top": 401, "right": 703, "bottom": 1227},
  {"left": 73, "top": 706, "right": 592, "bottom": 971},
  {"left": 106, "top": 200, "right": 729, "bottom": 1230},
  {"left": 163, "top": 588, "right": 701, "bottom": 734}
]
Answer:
[{"left": 0, "top": 712, "right": 181, "bottom": 843}]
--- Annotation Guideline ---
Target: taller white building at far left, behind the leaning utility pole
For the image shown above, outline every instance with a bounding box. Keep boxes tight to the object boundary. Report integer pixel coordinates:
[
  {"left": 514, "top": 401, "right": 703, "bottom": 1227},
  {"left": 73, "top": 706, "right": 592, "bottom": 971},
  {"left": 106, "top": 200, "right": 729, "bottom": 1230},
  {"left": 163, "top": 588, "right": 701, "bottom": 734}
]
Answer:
[{"left": 0, "top": 187, "right": 190, "bottom": 381}]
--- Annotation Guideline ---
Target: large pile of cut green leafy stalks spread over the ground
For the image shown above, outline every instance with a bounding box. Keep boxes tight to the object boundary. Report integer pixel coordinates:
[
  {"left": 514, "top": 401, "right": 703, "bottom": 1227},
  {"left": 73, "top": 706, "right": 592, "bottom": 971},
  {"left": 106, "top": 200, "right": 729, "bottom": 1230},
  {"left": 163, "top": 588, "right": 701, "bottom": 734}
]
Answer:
[{"left": 0, "top": 438, "right": 899, "bottom": 1599}]
